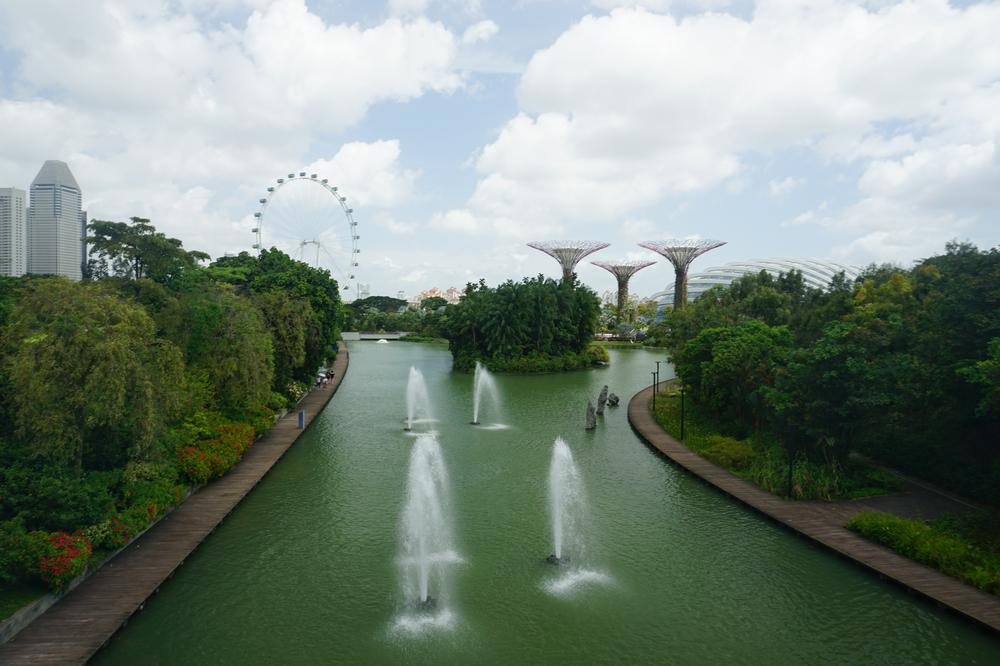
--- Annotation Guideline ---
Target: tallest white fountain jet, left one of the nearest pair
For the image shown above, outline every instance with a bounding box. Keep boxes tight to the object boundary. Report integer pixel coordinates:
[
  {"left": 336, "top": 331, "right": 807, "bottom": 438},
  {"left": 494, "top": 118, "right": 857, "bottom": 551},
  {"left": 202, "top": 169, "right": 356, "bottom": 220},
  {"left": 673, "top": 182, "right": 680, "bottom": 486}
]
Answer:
[{"left": 399, "top": 434, "right": 460, "bottom": 612}]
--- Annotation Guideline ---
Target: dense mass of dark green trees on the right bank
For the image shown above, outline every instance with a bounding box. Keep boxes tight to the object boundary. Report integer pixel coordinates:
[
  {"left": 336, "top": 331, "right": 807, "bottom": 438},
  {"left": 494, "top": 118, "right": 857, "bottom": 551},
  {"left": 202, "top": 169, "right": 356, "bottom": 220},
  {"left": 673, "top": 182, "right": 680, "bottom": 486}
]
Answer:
[{"left": 653, "top": 243, "right": 1000, "bottom": 504}]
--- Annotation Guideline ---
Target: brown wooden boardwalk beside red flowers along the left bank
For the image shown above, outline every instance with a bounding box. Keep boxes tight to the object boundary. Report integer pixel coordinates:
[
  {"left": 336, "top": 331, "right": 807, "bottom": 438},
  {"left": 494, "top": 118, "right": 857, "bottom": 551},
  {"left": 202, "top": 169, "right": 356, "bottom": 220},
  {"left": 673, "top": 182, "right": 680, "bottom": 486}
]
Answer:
[{"left": 0, "top": 343, "right": 348, "bottom": 666}]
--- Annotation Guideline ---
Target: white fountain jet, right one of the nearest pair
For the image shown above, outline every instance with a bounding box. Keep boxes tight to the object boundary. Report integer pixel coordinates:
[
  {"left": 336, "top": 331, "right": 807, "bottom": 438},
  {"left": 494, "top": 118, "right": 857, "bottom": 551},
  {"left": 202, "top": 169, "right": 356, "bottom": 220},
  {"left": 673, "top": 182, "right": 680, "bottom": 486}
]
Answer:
[{"left": 545, "top": 437, "right": 586, "bottom": 565}]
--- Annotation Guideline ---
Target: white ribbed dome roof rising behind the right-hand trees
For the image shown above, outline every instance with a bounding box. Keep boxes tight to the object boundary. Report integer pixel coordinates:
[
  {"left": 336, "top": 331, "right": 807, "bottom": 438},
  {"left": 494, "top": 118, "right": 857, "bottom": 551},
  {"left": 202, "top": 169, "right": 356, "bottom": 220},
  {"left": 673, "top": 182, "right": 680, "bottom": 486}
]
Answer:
[{"left": 651, "top": 259, "right": 861, "bottom": 314}]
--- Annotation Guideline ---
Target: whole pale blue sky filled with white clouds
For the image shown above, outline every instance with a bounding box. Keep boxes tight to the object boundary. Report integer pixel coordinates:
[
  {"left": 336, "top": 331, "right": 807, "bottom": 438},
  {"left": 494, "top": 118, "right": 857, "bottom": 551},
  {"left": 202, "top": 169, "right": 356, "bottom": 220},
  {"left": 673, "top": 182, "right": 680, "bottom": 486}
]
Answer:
[{"left": 0, "top": 0, "right": 1000, "bottom": 297}]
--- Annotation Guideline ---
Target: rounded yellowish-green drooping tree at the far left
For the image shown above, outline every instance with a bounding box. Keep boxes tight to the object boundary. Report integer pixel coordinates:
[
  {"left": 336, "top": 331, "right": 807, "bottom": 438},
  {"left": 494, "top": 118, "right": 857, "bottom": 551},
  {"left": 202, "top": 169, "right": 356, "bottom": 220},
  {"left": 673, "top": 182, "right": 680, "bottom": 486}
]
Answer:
[{"left": 4, "top": 279, "right": 183, "bottom": 476}]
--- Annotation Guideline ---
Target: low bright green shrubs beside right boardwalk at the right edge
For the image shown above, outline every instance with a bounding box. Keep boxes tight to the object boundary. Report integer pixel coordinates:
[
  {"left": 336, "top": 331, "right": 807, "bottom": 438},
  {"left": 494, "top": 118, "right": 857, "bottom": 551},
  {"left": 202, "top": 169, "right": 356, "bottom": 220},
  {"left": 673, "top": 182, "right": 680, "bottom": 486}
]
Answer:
[{"left": 847, "top": 512, "right": 1000, "bottom": 595}]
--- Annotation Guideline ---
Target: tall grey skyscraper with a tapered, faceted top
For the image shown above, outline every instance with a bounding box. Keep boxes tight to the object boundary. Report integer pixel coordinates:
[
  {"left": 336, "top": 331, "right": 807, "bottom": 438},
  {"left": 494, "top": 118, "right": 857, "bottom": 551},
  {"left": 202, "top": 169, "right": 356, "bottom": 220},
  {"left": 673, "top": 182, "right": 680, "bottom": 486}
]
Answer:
[{"left": 28, "top": 160, "right": 86, "bottom": 280}]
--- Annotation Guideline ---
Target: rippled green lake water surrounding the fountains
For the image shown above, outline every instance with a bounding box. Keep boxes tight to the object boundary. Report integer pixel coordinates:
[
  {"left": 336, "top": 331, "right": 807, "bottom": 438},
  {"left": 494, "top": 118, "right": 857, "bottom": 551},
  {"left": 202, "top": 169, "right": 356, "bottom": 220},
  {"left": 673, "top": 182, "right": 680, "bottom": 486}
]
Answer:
[{"left": 96, "top": 343, "right": 1000, "bottom": 665}]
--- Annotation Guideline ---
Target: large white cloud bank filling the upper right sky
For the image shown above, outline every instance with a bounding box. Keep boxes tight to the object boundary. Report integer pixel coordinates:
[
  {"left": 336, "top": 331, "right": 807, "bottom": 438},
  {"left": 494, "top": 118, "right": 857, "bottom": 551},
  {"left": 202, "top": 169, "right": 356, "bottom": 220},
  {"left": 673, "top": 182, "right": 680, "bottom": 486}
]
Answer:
[{"left": 444, "top": 0, "right": 1000, "bottom": 262}]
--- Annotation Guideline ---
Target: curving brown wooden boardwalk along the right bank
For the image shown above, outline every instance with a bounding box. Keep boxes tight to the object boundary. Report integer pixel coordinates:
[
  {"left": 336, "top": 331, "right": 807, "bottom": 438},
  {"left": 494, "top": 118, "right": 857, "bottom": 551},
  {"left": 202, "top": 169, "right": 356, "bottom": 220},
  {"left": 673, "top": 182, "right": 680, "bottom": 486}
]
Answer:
[{"left": 628, "top": 387, "right": 1000, "bottom": 632}]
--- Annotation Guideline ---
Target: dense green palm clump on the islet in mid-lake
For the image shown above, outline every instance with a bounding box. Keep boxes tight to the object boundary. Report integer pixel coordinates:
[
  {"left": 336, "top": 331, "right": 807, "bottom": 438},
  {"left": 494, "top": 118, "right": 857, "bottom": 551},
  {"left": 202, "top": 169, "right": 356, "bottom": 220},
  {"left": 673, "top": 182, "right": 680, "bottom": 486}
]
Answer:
[{"left": 445, "top": 275, "right": 600, "bottom": 372}]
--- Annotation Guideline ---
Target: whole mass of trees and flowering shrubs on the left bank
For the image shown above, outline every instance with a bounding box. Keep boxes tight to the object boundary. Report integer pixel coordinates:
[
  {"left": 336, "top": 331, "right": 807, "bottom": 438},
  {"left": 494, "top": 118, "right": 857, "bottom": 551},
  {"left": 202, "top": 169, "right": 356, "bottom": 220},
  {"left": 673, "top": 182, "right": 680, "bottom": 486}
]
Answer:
[{"left": 0, "top": 219, "right": 343, "bottom": 596}]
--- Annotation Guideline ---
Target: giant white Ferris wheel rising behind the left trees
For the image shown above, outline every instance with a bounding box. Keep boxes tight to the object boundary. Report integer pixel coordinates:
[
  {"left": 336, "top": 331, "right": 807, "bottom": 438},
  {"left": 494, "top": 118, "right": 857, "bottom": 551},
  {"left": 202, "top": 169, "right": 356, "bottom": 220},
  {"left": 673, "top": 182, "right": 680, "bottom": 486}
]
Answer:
[{"left": 252, "top": 171, "right": 361, "bottom": 290}]
